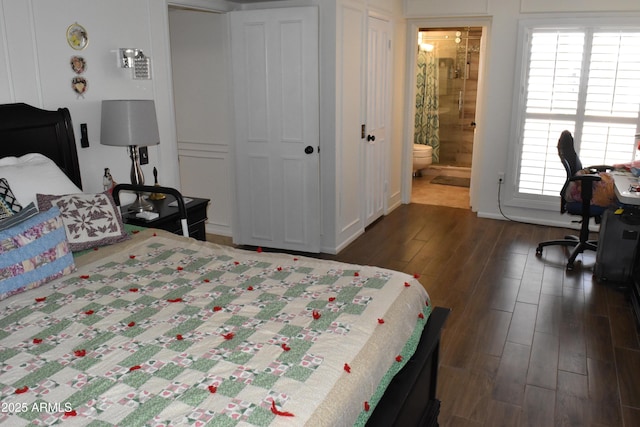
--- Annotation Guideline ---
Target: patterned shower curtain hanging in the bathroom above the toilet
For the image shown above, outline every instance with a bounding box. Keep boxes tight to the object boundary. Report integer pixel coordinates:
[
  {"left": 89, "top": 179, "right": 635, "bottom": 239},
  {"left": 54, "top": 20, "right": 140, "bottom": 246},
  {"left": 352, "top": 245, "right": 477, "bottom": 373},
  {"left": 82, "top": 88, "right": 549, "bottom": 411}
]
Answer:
[{"left": 413, "top": 49, "right": 440, "bottom": 163}]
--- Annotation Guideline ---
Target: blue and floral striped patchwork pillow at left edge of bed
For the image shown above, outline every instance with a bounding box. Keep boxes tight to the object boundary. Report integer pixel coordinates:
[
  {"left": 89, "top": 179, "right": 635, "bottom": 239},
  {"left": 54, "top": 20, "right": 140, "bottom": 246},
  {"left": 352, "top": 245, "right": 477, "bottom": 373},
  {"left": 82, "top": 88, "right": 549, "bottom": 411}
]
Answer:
[{"left": 0, "top": 208, "right": 75, "bottom": 300}]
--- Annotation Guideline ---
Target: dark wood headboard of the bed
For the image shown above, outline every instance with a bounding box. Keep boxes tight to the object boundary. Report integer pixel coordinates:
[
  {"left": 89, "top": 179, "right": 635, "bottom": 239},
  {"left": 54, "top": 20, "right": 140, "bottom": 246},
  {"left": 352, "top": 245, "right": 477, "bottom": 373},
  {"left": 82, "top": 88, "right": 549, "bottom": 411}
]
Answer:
[{"left": 0, "top": 103, "right": 82, "bottom": 188}]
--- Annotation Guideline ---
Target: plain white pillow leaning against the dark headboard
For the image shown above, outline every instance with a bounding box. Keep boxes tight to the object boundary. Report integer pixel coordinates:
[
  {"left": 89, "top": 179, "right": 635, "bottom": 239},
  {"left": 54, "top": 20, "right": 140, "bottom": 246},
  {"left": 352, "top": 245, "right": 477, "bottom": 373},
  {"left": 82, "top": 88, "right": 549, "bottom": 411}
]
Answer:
[{"left": 0, "top": 153, "right": 82, "bottom": 206}]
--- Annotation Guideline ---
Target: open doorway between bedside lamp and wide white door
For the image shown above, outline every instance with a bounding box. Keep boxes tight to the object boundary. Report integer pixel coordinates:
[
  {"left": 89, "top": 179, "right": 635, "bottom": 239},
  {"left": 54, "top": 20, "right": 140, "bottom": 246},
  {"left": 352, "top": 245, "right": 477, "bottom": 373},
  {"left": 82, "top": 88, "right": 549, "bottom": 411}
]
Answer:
[{"left": 168, "top": 5, "right": 233, "bottom": 236}]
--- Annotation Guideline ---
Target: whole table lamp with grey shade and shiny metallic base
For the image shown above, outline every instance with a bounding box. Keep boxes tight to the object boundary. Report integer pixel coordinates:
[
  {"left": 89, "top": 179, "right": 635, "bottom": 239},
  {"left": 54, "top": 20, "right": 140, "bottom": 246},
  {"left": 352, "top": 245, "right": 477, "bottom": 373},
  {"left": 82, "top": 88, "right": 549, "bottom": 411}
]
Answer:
[{"left": 100, "top": 99, "right": 160, "bottom": 212}]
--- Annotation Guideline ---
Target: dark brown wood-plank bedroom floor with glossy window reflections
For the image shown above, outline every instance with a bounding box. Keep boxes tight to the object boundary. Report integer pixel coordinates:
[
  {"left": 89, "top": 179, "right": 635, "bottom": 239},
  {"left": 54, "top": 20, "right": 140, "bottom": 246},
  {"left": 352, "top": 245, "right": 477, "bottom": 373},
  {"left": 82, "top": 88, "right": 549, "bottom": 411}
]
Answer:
[{"left": 209, "top": 204, "right": 640, "bottom": 427}]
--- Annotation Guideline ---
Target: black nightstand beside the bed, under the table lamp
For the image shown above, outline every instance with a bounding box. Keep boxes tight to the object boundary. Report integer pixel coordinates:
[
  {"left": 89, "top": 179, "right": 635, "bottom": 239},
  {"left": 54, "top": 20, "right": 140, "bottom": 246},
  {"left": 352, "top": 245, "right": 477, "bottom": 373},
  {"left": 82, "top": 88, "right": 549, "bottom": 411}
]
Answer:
[{"left": 121, "top": 194, "right": 209, "bottom": 241}]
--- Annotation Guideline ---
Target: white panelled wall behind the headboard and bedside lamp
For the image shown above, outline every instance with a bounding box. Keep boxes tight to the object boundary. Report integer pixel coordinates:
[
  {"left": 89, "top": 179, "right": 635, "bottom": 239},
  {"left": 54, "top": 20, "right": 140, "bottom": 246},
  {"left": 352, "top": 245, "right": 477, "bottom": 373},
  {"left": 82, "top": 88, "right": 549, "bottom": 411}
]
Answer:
[{"left": 0, "top": 0, "right": 178, "bottom": 191}]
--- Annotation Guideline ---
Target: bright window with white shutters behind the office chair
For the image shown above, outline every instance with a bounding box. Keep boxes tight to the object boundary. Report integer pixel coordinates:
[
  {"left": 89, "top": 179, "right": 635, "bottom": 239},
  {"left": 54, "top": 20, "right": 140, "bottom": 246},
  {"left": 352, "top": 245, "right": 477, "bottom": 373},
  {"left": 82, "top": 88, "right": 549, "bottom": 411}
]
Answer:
[{"left": 517, "top": 27, "right": 640, "bottom": 197}]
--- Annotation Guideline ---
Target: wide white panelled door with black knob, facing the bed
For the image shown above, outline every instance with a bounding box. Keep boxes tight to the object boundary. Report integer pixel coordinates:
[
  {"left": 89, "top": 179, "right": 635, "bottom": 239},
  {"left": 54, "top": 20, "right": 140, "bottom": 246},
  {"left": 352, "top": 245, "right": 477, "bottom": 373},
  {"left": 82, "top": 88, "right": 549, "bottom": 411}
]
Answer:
[{"left": 230, "top": 7, "right": 320, "bottom": 252}]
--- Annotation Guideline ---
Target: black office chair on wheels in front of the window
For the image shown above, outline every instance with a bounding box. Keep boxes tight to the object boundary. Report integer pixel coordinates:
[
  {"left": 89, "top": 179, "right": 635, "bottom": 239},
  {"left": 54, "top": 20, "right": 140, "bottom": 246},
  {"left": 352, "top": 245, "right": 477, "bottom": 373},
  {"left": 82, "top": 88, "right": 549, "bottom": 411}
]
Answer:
[{"left": 536, "top": 130, "right": 612, "bottom": 271}]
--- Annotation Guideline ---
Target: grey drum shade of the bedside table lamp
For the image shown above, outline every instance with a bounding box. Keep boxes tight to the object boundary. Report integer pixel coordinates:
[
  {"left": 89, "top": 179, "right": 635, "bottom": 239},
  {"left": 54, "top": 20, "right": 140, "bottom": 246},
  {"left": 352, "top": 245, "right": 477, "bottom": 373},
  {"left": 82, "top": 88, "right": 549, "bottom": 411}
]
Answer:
[{"left": 100, "top": 99, "right": 160, "bottom": 147}]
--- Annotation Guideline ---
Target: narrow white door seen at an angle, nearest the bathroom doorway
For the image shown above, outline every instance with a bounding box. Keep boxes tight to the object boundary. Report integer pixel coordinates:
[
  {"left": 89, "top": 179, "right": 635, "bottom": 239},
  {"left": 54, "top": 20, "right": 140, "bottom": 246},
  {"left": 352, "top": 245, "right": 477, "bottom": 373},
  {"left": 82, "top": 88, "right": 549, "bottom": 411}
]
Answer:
[{"left": 363, "top": 16, "right": 391, "bottom": 227}]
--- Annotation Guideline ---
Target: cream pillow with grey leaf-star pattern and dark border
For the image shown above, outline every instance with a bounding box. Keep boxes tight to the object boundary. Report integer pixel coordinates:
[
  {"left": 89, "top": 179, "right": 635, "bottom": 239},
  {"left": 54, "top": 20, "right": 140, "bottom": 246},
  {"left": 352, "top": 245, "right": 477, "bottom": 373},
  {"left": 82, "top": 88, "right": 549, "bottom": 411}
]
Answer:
[{"left": 36, "top": 192, "right": 130, "bottom": 252}]
